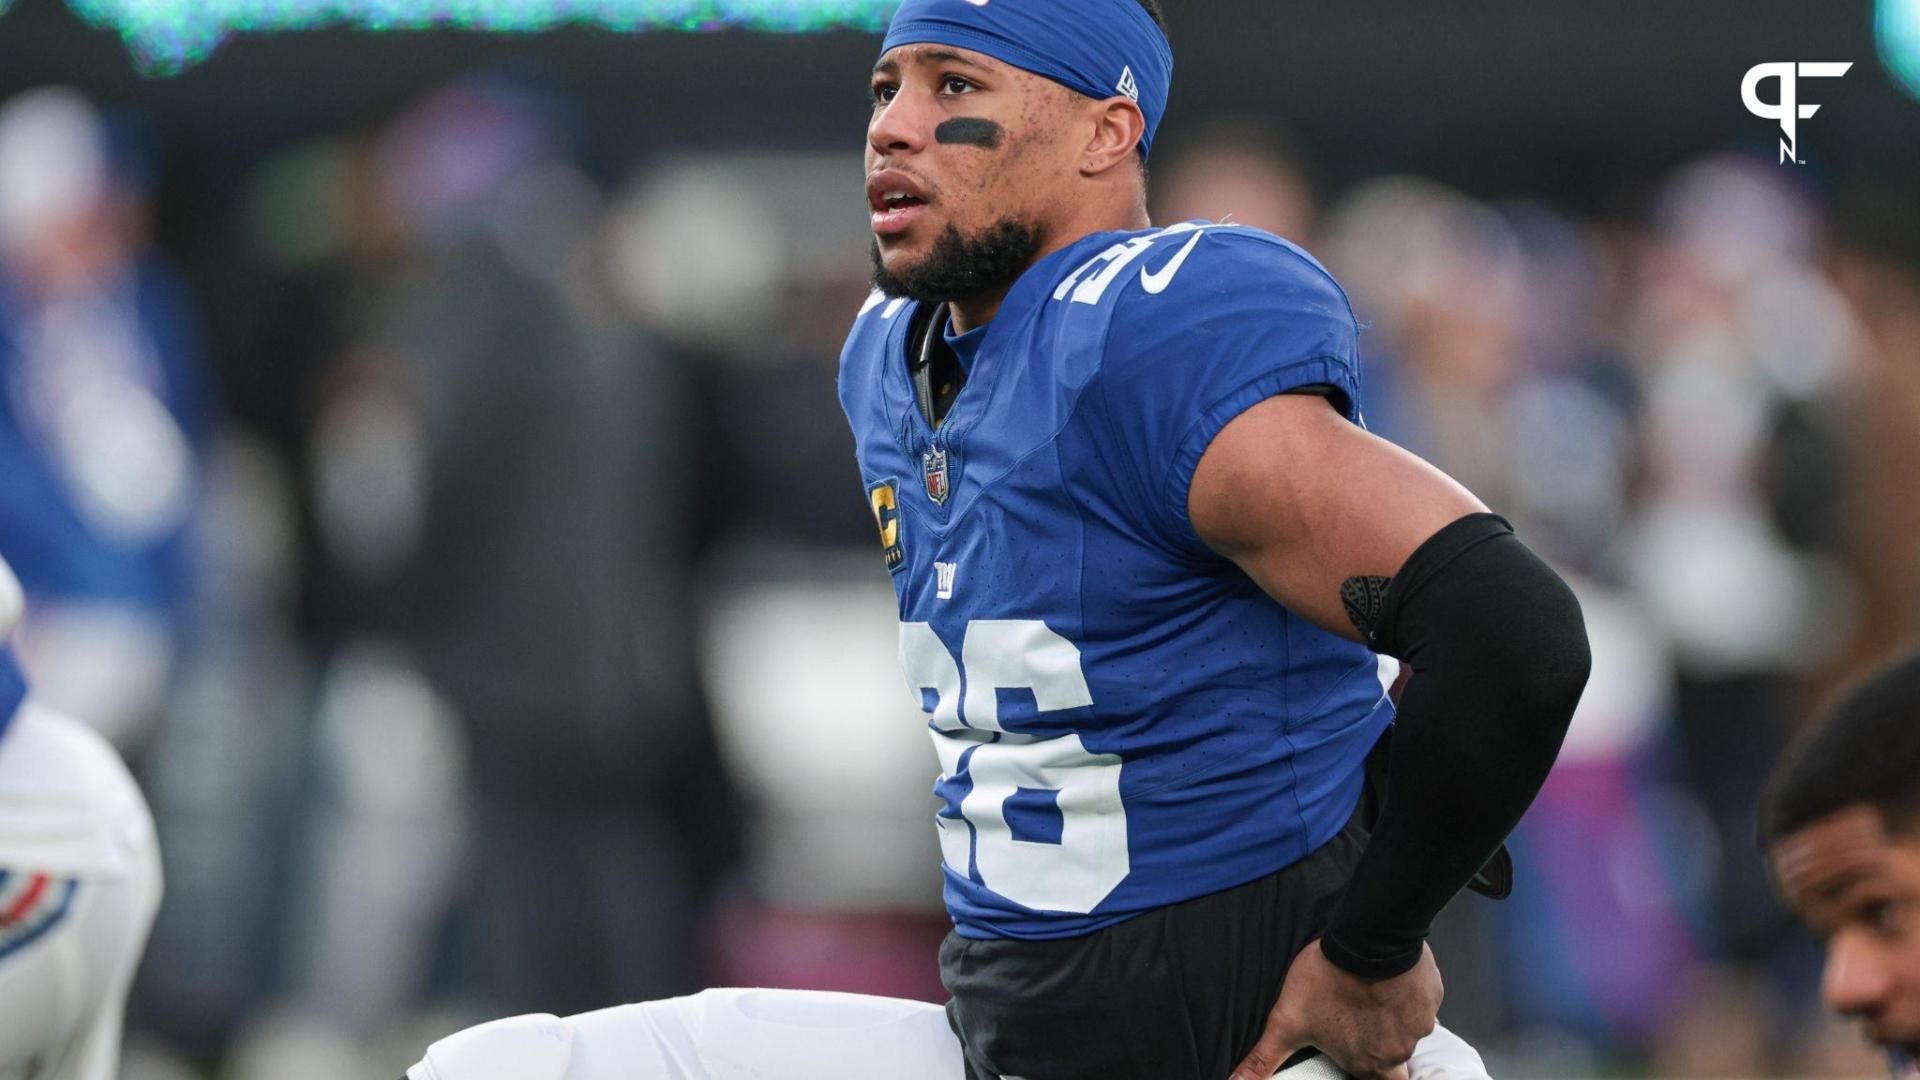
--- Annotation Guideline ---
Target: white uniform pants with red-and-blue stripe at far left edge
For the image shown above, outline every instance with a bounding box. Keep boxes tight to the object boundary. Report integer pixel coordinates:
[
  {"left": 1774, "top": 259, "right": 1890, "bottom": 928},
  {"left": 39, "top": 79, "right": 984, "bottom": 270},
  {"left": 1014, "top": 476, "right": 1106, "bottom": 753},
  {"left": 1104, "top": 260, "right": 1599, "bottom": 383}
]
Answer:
[{"left": 0, "top": 563, "right": 159, "bottom": 1080}]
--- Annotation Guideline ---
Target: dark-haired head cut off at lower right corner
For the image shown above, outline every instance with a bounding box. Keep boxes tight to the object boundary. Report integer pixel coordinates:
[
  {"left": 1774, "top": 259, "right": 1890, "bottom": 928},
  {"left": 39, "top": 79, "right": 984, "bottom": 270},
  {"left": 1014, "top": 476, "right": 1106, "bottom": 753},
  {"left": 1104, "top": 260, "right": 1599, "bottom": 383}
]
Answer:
[{"left": 1761, "top": 653, "right": 1920, "bottom": 1061}]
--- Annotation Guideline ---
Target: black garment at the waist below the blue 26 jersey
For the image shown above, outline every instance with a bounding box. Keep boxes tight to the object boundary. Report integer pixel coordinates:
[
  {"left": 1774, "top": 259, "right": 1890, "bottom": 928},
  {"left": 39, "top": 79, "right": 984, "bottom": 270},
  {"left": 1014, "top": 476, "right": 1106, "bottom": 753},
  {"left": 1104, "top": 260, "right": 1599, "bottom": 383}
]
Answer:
[{"left": 941, "top": 798, "right": 1373, "bottom": 1080}]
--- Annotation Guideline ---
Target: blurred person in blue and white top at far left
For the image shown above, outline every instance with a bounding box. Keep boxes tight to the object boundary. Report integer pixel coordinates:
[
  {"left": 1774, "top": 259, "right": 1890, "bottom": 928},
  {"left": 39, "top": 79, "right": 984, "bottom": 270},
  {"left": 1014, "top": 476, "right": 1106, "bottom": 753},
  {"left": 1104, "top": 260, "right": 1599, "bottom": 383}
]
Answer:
[{"left": 0, "top": 88, "right": 213, "bottom": 748}]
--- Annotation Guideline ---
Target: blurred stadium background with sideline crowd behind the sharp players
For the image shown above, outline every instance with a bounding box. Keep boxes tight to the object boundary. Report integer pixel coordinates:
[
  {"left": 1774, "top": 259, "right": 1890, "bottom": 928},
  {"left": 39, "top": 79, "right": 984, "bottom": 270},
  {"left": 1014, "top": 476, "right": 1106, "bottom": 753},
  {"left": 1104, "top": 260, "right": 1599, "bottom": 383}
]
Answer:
[{"left": 0, "top": 0, "right": 1920, "bottom": 1080}]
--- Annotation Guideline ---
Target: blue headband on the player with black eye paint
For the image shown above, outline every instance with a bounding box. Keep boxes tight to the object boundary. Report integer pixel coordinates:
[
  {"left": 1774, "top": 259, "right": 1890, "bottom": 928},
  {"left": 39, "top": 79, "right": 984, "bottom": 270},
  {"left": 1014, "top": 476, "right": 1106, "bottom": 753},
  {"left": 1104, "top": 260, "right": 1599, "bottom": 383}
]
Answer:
[{"left": 879, "top": 0, "right": 1173, "bottom": 158}]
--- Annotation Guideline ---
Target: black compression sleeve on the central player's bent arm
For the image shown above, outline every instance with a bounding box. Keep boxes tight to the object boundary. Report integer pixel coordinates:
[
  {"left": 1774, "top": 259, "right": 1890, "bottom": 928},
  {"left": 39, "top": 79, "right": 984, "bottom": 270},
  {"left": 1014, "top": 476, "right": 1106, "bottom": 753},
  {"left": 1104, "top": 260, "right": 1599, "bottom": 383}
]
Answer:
[{"left": 1321, "top": 513, "right": 1592, "bottom": 978}]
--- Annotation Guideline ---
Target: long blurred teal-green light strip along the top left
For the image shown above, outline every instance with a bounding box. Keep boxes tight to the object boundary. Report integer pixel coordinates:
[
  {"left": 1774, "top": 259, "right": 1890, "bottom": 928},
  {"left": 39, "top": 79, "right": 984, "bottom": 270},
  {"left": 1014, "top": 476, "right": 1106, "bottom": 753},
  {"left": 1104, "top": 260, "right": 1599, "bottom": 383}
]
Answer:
[{"left": 60, "top": 0, "right": 900, "bottom": 75}]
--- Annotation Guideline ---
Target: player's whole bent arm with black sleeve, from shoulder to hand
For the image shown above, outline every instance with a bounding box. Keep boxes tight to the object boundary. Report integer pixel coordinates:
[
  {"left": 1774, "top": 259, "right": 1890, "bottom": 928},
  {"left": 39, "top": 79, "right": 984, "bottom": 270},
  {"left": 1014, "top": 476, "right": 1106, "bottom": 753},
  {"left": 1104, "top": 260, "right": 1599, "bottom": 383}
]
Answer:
[{"left": 1188, "top": 394, "right": 1588, "bottom": 1080}]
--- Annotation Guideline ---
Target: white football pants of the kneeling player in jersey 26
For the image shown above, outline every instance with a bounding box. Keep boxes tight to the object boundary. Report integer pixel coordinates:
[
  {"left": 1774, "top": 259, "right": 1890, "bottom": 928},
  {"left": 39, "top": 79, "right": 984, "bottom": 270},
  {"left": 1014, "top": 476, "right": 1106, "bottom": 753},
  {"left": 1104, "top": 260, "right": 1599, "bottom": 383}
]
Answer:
[{"left": 407, "top": 990, "right": 1486, "bottom": 1080}]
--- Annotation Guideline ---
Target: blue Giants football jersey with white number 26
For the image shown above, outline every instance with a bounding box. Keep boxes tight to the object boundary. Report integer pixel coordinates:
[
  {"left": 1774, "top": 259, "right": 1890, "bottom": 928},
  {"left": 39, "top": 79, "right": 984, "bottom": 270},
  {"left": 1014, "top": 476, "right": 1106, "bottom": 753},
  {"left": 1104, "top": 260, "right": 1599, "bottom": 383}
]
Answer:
[{"left": 839, "top": 223, "right": 1396, "bottom": 938}]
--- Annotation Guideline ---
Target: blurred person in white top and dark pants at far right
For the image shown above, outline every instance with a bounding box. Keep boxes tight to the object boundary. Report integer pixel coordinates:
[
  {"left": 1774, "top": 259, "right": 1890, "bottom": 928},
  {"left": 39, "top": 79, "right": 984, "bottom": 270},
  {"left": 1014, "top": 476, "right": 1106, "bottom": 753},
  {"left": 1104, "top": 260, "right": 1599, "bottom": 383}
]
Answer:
[{"left": 1617, "top": 158, "right": 1862, "bottom": 1074}]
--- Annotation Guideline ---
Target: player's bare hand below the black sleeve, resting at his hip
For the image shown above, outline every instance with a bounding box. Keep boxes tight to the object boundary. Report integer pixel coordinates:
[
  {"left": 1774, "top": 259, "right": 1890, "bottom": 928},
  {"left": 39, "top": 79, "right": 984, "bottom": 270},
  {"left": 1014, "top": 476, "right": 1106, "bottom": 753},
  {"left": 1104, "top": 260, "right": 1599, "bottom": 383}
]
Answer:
[{"left": 1229, "top": 940, "right": 1446, "bottom": 1080}]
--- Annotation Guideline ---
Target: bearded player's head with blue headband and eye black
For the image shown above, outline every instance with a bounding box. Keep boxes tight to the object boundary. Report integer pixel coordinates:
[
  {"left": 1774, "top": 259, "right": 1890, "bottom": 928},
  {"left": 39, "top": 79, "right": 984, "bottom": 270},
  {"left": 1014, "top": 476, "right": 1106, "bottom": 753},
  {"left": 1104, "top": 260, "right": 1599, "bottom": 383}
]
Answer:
[{"left": 866, "top": 0, "right": 1173, "bottom": 302}]
